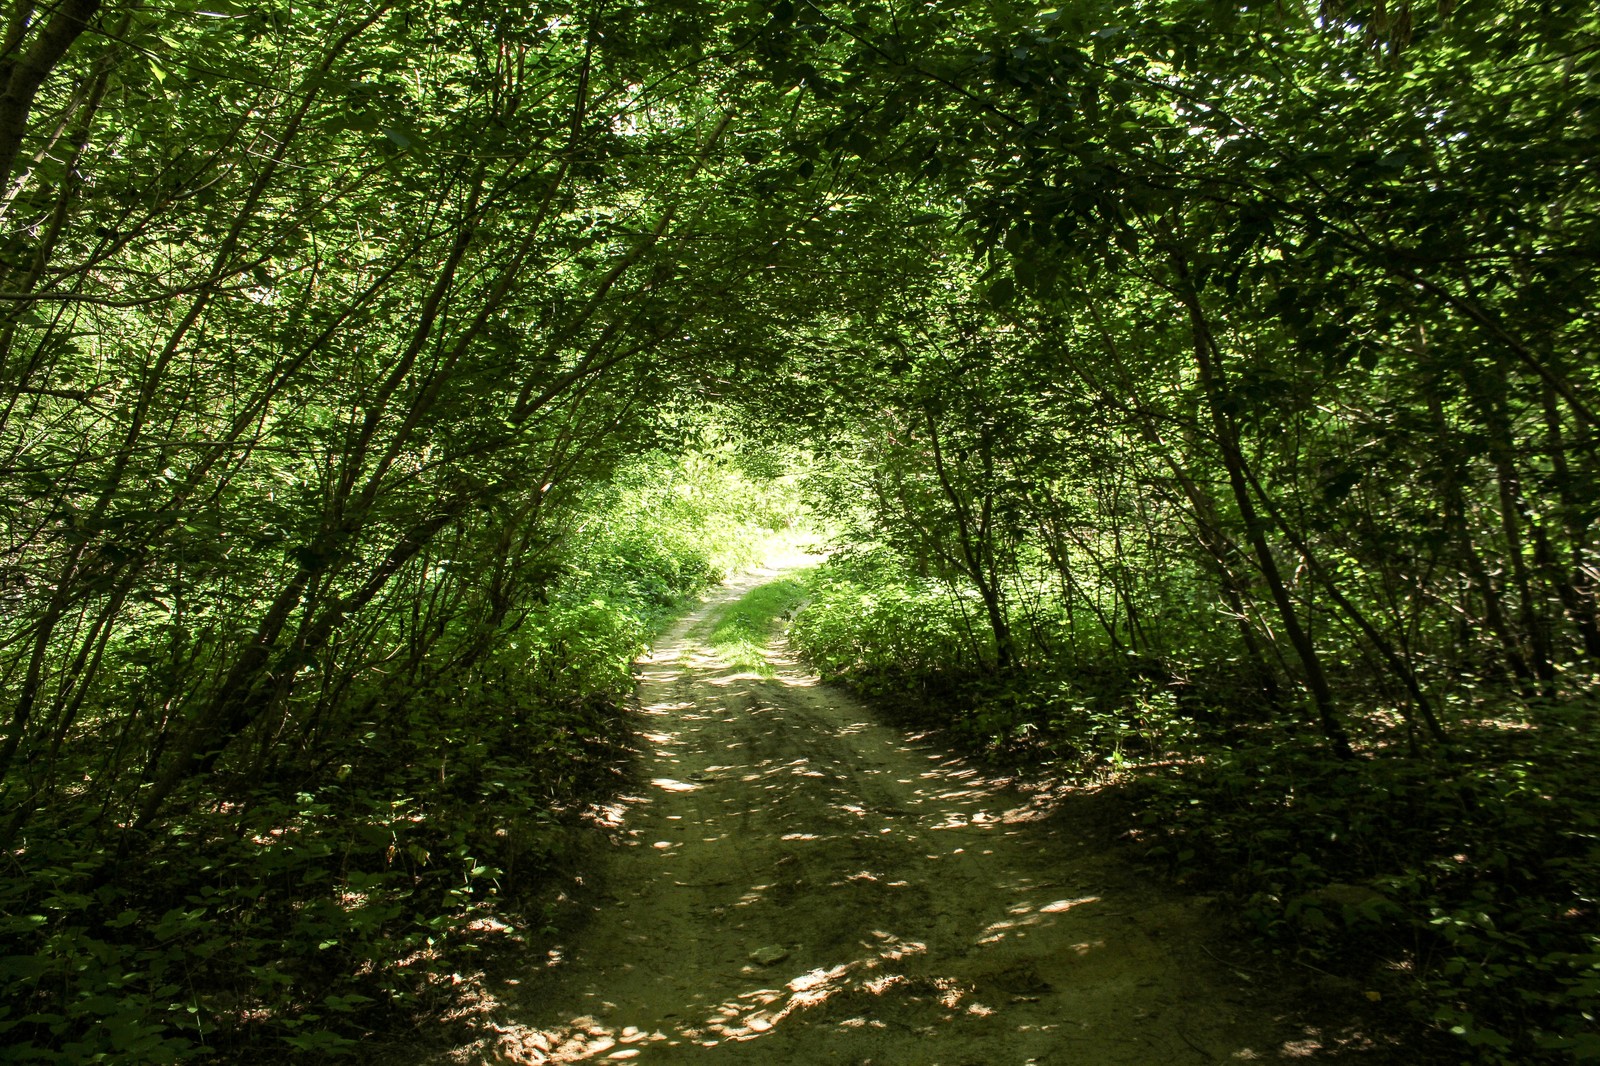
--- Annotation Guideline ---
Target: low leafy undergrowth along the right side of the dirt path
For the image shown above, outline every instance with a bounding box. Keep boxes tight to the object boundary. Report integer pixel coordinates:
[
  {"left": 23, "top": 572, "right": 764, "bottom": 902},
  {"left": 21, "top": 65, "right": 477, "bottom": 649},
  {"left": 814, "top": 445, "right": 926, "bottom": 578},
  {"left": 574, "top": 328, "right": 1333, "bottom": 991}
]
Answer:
[{"left": 790, "top": 550, "right": 1600, "bottom": 1066}]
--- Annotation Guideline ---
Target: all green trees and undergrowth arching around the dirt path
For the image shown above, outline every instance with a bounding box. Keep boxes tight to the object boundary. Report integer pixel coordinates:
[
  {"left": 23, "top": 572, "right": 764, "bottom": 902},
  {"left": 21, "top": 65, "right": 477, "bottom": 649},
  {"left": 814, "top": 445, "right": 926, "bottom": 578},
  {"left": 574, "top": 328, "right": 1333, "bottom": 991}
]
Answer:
[{"left": 0, "top": 0, "right": 1600, "bottom": 1061}]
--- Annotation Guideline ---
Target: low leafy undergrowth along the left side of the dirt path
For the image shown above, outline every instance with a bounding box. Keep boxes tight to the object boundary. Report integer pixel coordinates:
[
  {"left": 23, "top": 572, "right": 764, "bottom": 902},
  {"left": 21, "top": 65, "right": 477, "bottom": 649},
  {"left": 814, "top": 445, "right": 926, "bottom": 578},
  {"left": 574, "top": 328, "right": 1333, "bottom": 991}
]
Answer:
[{"left": 0, "top": 458, "right": 795, "bottom": 1066}]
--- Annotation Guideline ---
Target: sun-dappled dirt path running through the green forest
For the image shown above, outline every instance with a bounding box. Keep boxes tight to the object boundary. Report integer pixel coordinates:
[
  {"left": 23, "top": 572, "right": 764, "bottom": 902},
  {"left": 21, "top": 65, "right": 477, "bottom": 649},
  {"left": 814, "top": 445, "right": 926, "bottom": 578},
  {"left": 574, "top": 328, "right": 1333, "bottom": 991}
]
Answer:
[{"left": 477, "top": 557, "right": 1317, "bottom": 1066}]
